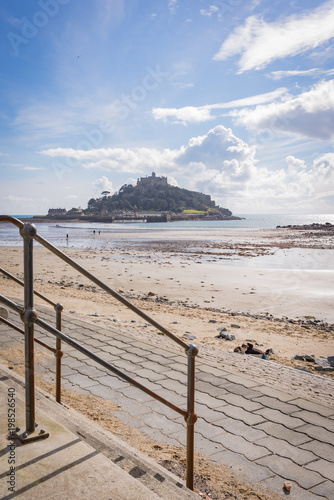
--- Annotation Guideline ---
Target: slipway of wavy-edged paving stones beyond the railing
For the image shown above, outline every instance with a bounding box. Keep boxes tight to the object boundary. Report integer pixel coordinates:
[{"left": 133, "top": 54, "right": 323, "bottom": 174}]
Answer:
[{"left": 0, "top": 308, "right": 334, "bottom": 500}]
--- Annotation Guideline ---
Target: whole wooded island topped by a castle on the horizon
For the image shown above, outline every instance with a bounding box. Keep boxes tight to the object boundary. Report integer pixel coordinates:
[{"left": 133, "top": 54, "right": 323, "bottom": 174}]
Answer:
[{"left": 34, "top": 172, "right": 241, "bottom": 222}]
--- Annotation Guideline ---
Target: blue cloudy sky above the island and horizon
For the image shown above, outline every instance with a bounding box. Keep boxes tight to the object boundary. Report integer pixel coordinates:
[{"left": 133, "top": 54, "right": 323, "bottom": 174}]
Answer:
[{"left": 0, "top": 0, "right": 334, "bottom": 215}]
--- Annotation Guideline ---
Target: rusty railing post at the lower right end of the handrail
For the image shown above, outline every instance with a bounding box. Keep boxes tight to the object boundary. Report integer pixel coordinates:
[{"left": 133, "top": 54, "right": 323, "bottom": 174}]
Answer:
[{"left": 185, "top": 344, "right": 198, "bottom": 490}]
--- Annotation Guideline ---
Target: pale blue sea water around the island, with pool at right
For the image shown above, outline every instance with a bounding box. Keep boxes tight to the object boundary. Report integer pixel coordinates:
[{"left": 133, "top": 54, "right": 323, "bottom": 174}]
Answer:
[{"left": 0, "top": 214, "right": 334, "bottom": 270}]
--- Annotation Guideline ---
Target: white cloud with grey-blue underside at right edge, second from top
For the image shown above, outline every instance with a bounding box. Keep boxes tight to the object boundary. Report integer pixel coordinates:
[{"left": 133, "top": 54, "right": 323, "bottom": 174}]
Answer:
[{"left": 237, "top": 80, "right": 334, "bottom": 140}]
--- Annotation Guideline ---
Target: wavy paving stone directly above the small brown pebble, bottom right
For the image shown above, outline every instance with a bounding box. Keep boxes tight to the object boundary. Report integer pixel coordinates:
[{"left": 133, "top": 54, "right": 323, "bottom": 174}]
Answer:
[{"left": 256, "top": 455, "right": 324, "bottom": 489}]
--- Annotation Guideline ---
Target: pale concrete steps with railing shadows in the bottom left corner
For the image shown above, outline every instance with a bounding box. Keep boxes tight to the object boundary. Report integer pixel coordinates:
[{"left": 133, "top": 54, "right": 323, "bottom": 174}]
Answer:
[{"left": 0, "top": 365, "right": 199, "bottom": 500}]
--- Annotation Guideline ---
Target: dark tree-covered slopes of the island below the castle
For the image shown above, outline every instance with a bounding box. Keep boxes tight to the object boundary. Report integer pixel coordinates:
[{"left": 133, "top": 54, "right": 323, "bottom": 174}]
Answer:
[{"left": 85, "top": 184, "right": 232, "bottom": 216}]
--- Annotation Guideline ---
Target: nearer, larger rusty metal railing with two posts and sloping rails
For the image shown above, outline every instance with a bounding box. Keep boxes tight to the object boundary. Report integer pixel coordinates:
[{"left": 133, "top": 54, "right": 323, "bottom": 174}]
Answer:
[{"left": 0, "top": 215, "right": 198, "bottom": 490}]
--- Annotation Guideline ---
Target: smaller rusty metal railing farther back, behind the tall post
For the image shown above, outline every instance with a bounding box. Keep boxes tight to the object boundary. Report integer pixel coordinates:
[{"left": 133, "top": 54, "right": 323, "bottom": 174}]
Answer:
[{"left": 0, "top": 267, "right": 64, "bottom": 403}]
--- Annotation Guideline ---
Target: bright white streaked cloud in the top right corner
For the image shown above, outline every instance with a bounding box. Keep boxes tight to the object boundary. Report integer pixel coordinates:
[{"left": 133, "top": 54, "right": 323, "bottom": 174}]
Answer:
[{"left": 214, "top": 0, "right": 334, "bottom": 73}]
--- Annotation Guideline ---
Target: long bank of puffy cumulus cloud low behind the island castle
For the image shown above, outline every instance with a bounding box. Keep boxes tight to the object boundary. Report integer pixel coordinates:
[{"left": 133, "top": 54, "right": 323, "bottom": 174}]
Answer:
[{"left": 39, "top": 125, "right": 334, "bottom": 213}]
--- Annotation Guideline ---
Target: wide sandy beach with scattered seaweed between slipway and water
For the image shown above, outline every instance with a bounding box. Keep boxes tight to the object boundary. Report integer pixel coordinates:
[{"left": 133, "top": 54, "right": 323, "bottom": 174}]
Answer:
[{"left": 0, "top": 225, "right": 334, "bottom": 378}]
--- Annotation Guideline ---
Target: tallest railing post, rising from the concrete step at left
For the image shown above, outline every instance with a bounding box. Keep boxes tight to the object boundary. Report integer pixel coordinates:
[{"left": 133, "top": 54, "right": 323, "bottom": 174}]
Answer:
[{"left": 20, "top": 223, "right": 37, "bottom": 433}]
